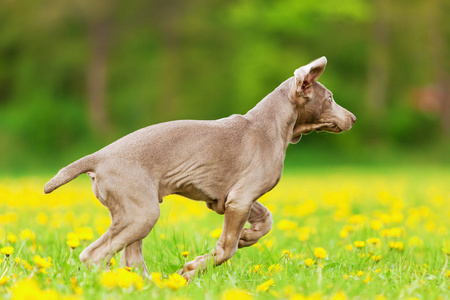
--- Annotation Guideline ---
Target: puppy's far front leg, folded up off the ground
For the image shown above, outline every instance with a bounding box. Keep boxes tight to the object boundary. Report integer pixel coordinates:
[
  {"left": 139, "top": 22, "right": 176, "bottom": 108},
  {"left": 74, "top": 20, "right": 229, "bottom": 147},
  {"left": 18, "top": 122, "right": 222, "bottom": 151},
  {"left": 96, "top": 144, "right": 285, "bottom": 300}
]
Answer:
[{"left": 239, "top": 202, "right": 273, "bottom": 248}]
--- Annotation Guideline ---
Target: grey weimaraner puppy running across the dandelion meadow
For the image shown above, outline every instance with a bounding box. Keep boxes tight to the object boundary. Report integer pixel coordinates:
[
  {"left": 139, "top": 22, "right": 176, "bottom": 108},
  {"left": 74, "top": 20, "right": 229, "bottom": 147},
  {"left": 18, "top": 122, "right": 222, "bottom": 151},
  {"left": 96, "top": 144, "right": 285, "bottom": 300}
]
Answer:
[{"left": 44, "top": 57, "right": 356, "bottom": 280}]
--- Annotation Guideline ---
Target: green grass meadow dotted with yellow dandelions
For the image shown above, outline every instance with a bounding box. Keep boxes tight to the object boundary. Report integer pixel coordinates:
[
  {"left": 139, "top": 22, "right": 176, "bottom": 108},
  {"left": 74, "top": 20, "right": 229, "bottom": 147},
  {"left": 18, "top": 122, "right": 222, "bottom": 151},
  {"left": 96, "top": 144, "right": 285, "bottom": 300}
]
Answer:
[{"left": 0, "top": 167, "right": 450, "bottom": 300}]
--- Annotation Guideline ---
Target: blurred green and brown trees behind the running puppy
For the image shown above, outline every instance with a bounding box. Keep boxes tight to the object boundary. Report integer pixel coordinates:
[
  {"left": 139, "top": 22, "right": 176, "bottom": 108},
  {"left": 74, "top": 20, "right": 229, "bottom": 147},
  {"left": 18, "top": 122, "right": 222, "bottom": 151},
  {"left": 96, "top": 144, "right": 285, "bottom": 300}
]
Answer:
[{"left": 0, "top": 0, "right": 450, "bottom": 170}]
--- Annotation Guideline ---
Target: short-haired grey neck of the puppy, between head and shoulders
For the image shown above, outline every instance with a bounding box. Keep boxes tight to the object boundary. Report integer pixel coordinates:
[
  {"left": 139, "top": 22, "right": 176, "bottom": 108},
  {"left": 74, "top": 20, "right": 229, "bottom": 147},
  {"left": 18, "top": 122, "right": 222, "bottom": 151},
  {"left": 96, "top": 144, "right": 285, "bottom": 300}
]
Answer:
[{"left": 245, "top": 77, "right": 298, "bottom": 151}]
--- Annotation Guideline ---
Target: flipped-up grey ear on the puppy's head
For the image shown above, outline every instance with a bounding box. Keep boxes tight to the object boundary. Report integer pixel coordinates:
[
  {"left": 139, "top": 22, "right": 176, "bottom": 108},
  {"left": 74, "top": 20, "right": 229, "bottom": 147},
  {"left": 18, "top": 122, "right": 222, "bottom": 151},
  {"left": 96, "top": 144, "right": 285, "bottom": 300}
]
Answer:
[{"left": 294, "top": 56, "right": 327, "bottom": 96}]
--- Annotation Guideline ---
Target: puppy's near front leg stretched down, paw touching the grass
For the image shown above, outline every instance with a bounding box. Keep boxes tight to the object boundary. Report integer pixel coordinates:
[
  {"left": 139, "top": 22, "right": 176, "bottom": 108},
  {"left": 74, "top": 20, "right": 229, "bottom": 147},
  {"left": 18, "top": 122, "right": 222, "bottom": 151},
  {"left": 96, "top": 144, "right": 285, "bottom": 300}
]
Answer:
[{"left": 179, "top": 200, "right": 253, "bottom": 281}]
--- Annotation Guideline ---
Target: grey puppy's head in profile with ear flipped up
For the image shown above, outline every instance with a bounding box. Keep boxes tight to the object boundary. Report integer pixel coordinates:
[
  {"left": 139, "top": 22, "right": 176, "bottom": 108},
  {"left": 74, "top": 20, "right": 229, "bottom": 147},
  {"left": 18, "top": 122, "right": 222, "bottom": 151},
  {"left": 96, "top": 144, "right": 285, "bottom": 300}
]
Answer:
[{"left": 290, "top": 56, "right": 356, "bottom": 143}]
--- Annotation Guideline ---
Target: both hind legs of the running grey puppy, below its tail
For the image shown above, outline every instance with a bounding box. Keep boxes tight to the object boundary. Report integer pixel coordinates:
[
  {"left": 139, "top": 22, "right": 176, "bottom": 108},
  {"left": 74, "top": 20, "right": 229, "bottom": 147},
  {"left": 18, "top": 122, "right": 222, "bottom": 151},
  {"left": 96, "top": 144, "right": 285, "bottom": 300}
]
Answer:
[{"left": 80, "top": 169, "right": 160, "bottom": 271}]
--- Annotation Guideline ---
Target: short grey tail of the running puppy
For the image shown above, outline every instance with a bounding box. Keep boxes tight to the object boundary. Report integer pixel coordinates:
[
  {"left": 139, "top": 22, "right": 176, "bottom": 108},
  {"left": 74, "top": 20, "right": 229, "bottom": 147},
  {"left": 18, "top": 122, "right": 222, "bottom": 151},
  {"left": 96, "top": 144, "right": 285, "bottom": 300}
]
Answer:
[{"left": 44, "top": 154, "right": 97, "bottom": 194}]
